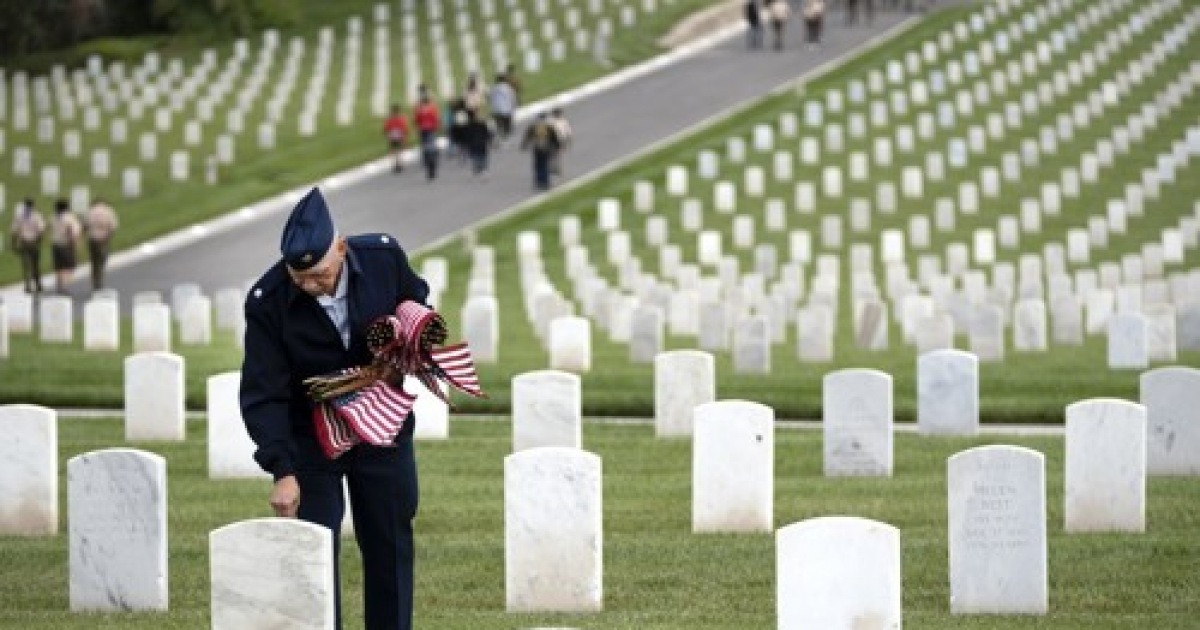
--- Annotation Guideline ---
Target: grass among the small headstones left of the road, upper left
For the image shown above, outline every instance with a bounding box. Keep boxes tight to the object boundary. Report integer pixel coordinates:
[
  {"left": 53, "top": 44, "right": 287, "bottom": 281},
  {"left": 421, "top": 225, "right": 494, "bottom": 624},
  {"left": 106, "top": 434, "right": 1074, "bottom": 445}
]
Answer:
[{"left": 0, "top": 0, "right": 715, "bottom": 284}]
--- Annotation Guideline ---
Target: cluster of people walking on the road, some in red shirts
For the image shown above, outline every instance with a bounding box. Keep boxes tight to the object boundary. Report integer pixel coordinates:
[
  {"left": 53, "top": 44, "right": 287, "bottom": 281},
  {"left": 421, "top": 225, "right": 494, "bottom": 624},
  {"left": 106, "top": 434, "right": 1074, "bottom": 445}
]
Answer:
[{"left": 383, "top": 66, "right": 572, "bottom": 190}]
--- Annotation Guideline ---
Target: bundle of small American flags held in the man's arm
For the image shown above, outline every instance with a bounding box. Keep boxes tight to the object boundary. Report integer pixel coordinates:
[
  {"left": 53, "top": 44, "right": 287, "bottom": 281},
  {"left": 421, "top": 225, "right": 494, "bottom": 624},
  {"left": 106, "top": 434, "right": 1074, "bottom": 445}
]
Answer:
[{"left": 305, "top": 301, "right": 485, "bottom": 460}]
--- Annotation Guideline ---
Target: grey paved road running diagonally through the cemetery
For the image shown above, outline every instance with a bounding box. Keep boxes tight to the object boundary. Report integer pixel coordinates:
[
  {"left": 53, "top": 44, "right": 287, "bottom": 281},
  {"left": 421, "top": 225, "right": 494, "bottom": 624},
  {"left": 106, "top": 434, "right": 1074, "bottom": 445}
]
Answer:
[{"left": 72, "top": 4, "right": 914, "bottom": 296}]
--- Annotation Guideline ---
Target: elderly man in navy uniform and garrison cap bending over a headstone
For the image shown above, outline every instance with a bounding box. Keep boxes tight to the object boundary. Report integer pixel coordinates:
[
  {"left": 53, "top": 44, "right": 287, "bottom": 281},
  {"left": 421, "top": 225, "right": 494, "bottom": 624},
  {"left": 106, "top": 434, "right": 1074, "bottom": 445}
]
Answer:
[{"left": 240, "top": 188, "right": 428, "bottom": 630}]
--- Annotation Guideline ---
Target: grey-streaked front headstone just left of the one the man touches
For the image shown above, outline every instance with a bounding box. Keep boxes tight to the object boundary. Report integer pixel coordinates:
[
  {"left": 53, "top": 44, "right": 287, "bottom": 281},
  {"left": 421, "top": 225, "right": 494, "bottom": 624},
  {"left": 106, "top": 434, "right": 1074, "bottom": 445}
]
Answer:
[{"left": 67, "top": 449, "right": 168, "bottom": 611}]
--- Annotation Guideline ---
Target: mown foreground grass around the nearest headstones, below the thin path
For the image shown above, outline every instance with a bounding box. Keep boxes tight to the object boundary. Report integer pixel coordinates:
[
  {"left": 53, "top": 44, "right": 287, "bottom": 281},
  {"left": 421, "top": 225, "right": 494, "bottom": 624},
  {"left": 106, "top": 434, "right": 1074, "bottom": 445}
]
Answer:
[{"left": 0, "top": 419, "right": 1200, "bottom": 630}]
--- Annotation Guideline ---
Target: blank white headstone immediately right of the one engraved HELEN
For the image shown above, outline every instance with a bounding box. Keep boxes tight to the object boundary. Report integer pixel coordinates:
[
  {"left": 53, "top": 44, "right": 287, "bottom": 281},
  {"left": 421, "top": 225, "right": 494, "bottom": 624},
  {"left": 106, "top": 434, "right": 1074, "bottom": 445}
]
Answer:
[{"left": 1063, "top": 398, "right": 1146, "bottom": 532}]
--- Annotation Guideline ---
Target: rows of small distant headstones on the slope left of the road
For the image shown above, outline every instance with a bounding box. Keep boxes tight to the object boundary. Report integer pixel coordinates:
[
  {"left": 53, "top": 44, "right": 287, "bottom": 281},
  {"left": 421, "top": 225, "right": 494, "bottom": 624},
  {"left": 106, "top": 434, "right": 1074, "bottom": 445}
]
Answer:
[{"left": 0, "top": 0, "right": 656, "bottom": 169}]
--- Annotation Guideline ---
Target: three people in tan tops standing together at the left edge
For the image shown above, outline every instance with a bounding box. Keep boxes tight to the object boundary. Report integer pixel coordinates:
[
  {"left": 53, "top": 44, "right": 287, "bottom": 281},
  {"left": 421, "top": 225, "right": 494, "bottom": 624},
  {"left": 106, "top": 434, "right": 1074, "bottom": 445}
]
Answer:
[{"left": 8, "top": 198, "right": 116, "bottom": 294}]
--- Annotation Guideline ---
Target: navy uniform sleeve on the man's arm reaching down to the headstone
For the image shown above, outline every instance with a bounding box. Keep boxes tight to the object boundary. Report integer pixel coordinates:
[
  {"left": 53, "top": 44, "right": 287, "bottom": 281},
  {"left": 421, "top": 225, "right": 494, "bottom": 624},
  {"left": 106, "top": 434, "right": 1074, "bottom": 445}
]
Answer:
[{"left": 240, "top": 292, "right": 295, "bottom": 480}]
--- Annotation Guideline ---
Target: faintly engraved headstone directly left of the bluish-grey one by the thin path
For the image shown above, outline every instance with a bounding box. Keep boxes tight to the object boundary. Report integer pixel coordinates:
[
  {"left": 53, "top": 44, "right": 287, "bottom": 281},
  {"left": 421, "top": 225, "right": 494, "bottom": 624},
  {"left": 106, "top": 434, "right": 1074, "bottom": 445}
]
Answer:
[{"left": 821, "top": 368, "right": 893, "bottom": 476}]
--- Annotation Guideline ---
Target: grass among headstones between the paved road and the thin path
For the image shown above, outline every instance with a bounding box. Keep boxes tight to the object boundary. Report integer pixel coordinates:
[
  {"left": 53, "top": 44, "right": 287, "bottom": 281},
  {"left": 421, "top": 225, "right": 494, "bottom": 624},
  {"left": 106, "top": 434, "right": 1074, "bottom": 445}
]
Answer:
[{"left": 0, "top": 2, "right": 1200, "bottom": 424}]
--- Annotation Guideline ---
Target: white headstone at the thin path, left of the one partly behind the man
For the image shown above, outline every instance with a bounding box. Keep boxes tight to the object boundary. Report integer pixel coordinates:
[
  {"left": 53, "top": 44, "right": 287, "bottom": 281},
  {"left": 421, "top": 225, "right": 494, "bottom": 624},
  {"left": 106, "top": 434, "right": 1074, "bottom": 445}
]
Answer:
[{"left": 125, "top": 352, "right": 187, "bottom": 442}]
